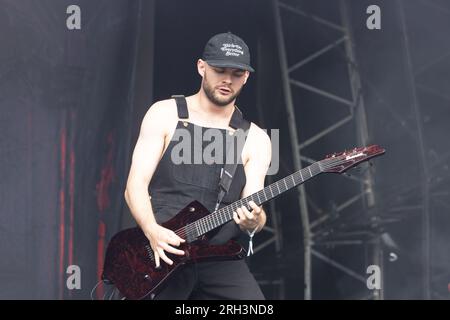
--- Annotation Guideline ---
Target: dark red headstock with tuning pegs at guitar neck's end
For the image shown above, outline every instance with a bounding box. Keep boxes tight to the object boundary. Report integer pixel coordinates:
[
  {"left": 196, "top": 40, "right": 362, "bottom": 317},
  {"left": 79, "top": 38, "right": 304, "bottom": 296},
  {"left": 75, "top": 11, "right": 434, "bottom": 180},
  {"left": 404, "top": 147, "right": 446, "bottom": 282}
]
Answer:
[{"left": 320, "top": 145, "right": 386, "bottom": 173}]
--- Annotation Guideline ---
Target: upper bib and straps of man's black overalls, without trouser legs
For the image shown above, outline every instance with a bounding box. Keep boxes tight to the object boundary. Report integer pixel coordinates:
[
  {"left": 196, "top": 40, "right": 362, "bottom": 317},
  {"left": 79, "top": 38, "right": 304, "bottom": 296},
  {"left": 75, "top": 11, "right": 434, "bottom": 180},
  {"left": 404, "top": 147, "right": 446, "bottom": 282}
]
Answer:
[{"left": 149, "top": 96, "right": 246, "bottom": 244}]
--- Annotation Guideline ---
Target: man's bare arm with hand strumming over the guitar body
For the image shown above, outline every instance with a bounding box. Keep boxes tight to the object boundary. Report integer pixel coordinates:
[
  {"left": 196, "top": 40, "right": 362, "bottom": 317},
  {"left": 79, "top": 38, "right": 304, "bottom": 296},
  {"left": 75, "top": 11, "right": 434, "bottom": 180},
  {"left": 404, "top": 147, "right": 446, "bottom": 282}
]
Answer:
[{"left": 125, "top": 102, "right": 184, "bottom": 266}]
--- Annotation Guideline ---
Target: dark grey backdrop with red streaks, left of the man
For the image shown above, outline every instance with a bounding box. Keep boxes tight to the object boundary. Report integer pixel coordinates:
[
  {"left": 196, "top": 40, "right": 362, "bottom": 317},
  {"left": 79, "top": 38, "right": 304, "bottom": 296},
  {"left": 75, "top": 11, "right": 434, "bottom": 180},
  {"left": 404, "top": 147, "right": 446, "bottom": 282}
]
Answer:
[{"left": 0, "top": 1, "right": 145, "bottom": 299}]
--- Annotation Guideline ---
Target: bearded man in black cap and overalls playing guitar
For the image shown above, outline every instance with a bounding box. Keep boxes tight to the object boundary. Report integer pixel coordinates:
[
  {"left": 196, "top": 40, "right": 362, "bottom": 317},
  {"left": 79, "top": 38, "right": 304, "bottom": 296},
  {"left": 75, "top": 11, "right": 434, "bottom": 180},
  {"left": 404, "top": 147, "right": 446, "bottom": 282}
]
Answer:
[{"left": 125, "top": 32, "right": 271, "bottom": 299}]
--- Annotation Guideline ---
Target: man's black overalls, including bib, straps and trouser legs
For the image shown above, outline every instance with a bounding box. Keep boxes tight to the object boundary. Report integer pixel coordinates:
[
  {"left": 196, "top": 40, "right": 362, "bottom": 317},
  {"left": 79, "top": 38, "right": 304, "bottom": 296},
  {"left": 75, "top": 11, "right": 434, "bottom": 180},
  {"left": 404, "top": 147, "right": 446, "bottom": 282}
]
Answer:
[{"left": 149, "top": 97, "right": 264, "bottom": 299}]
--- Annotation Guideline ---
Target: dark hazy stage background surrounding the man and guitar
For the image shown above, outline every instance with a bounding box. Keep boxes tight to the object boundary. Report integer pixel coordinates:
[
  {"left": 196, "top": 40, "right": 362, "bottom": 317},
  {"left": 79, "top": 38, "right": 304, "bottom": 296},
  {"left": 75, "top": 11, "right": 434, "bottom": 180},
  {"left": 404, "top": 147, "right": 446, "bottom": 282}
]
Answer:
[{"left": 0, "top": 0, "right": 450, "bottom": 299}]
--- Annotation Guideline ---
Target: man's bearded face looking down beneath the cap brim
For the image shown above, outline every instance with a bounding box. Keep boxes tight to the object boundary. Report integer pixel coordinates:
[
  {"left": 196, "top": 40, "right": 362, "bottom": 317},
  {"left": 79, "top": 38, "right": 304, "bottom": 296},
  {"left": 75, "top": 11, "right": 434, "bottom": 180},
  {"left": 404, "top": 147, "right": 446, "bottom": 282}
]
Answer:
[{"left": 199, "top": 61, "right": 249, "bottom": 107}]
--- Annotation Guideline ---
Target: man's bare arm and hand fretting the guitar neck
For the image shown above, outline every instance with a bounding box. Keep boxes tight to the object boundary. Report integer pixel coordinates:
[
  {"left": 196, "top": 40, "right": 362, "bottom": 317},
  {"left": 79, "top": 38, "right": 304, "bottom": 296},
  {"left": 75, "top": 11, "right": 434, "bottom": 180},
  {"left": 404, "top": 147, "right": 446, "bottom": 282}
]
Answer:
[{"left": 233, "top": 124, "right": 272, "bottom": 232}]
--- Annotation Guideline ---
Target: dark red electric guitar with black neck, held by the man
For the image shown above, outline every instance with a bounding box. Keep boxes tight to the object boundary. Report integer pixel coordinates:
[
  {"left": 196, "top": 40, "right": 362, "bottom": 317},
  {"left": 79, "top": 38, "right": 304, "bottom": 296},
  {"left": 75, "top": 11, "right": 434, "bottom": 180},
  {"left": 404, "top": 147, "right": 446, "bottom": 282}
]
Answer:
[{"left": 102, "top": 145, "right": 385, "bottom": 299}]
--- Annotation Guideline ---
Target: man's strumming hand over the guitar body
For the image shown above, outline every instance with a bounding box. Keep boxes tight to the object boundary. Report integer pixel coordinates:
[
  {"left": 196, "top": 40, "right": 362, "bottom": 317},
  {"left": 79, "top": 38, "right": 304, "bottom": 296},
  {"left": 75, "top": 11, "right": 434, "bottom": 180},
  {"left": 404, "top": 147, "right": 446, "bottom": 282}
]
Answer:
[{"left": 144, "top": 223, "right": 186, "bottom": 268}]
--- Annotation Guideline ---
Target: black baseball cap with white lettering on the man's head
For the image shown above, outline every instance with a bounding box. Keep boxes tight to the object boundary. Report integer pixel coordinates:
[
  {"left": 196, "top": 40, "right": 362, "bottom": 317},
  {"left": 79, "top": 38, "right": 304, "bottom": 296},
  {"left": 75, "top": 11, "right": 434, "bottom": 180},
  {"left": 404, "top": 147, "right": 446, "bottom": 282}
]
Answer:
[{"left": 202, "top": 32, "right": 255, "bottom": 72}]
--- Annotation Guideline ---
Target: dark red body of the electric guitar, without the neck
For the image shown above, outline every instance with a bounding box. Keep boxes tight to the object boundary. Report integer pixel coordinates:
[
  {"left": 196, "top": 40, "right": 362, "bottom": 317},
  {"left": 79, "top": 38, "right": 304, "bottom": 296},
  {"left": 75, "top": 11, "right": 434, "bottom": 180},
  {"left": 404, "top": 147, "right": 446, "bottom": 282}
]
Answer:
[{"left": 102, "top": 201, "right": 245, "bottom": 299}]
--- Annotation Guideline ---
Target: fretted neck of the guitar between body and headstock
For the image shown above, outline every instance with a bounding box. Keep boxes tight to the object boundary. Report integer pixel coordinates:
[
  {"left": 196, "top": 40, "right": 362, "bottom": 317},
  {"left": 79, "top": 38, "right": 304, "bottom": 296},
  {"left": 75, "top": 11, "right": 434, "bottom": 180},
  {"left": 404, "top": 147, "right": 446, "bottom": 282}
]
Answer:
[{"left": 191, "top": 161, "right": 323, "bottom": 236}]
